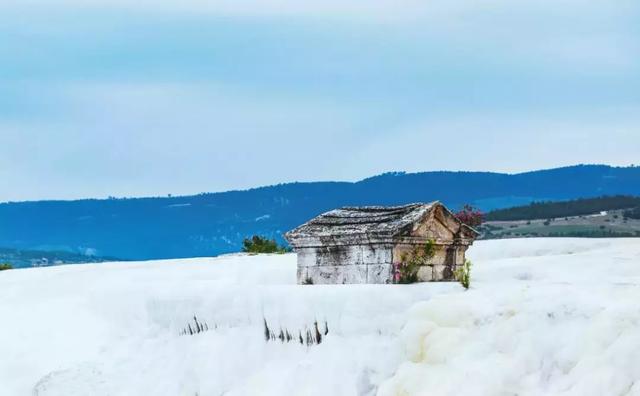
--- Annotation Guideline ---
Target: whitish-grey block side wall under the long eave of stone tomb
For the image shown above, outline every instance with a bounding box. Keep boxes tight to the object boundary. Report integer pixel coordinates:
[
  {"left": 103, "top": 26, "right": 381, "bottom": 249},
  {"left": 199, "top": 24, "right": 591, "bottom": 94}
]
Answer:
[{"left": 296, "top": 244, "right": 393, "bottom": 284}]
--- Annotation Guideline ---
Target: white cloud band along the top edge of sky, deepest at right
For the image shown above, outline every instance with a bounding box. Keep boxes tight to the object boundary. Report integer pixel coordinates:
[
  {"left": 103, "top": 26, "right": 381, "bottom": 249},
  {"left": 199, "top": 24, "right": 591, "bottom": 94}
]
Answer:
[{"left": 0, "top": 0, "right": 640, "bottom": 75}]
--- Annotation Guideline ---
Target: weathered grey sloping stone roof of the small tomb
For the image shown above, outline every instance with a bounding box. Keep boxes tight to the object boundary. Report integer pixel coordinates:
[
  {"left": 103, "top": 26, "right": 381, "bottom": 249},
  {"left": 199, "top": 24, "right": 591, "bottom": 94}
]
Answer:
[{"left": 285, "top": 201, "right": 448, "bottom": 247}]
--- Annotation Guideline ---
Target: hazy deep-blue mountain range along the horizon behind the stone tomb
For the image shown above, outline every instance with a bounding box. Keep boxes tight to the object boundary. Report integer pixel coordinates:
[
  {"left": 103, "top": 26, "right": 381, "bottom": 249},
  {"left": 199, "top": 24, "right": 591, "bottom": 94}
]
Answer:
[{"left": 0, "top": 165, "right": 640, "bottom": 260}]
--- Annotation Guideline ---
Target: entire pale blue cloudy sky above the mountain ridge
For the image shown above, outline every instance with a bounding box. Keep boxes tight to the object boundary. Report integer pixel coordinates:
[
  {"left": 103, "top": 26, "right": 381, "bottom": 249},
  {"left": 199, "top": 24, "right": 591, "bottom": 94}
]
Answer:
[{"left": 0, "top": 0, "right": 640, "bottom": 201}]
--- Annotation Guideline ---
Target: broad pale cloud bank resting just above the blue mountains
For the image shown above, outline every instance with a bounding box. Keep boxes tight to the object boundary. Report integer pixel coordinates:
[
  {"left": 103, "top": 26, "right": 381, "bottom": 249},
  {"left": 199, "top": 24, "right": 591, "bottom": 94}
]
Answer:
[{"left": 0, "top": 80, "right": 640, "bottom": 200}]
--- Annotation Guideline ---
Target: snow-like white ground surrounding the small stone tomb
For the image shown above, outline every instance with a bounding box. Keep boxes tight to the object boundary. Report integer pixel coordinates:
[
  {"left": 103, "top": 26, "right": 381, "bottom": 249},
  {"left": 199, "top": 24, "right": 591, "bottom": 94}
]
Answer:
[{"left": 0, "top": 239, "right": 640, "bottom": 396}]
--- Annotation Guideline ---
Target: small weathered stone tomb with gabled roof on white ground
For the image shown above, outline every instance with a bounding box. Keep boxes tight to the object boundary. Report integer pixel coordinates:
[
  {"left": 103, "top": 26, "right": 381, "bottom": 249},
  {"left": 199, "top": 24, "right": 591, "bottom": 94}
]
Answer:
[{"left": 285, "top": 202, "right": 478, "bottom": 284}]
